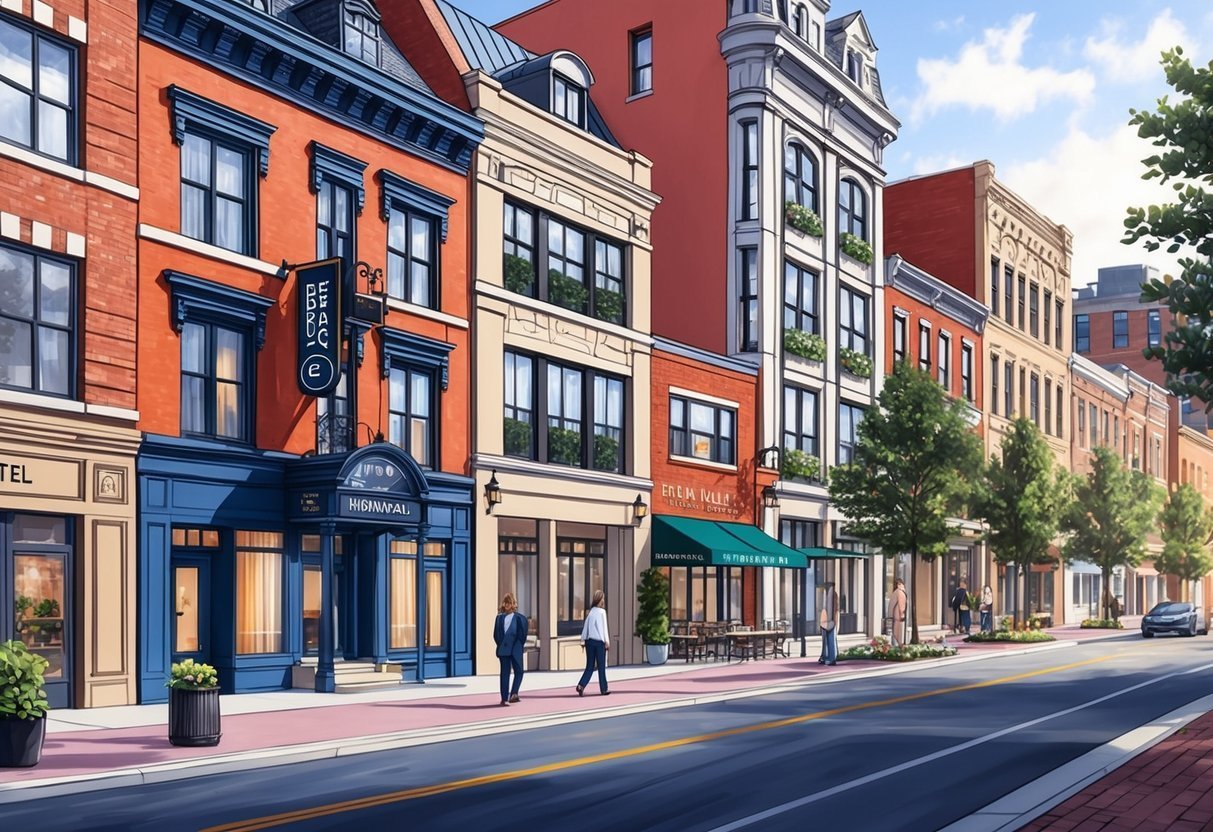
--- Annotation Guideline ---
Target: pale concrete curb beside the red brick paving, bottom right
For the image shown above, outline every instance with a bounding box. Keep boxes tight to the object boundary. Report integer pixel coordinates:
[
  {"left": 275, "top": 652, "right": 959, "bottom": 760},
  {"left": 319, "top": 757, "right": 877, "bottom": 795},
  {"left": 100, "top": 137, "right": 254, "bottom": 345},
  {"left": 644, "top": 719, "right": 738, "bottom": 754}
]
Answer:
[{"left": 940, "top": 695, "right": 1213, "bottom": 832}]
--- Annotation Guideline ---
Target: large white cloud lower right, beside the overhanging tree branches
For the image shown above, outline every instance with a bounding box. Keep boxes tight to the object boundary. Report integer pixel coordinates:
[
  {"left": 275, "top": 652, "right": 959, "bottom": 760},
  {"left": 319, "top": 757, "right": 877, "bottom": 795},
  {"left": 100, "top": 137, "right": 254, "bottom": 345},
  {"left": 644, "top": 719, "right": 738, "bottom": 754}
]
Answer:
[{"left": 997, "top": 125, "right": 1179, "bottom": 292}]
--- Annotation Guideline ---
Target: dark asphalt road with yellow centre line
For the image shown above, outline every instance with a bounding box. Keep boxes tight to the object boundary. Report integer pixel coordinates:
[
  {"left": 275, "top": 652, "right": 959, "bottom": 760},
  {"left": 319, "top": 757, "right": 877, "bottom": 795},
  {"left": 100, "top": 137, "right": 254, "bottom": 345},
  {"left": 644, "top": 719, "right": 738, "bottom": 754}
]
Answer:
[{"left": 9, "top": 638, "right": 1213, "bottom": 832}]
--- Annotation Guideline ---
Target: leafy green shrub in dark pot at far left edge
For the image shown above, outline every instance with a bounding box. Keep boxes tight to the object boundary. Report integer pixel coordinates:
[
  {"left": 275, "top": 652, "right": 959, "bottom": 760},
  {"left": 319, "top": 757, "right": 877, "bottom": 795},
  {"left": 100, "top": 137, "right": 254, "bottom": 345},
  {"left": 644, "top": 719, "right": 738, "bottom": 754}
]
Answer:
[{"left": 0, "top": 640, "right": 50, "bottom": 768}]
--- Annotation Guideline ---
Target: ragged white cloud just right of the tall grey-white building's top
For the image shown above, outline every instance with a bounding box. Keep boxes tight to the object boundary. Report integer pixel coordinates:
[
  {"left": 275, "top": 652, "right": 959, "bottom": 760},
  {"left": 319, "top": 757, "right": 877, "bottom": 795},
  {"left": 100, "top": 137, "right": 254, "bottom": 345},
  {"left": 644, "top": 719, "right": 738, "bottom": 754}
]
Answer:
[{"left": 910, "top": 15, "right": 1095, "bottom": 121}]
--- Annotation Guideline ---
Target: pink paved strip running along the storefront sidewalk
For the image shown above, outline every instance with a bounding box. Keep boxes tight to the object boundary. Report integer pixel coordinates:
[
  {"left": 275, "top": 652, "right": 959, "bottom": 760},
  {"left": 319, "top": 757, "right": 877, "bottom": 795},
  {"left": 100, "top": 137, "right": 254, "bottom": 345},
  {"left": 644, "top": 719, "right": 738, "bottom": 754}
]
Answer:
[{"left": 0, "top": 628, "right": 1135, "bottom": 783}]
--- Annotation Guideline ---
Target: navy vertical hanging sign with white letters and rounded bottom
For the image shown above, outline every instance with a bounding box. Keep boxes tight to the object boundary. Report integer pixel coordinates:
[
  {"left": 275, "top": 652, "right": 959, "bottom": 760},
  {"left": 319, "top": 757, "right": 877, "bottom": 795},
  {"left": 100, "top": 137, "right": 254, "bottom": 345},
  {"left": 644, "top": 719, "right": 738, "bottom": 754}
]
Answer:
[{"left": 295, "top": 257, "right": 341, "bottom": 395}]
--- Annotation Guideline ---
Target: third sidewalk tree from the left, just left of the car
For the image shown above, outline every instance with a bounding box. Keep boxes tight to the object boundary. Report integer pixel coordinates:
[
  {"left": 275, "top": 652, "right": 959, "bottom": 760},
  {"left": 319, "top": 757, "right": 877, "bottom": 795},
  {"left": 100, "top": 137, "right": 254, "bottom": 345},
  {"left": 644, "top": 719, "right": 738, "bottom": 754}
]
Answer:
[{"left": 1061, "top": 446, "right": 1162, "bottom": 619}]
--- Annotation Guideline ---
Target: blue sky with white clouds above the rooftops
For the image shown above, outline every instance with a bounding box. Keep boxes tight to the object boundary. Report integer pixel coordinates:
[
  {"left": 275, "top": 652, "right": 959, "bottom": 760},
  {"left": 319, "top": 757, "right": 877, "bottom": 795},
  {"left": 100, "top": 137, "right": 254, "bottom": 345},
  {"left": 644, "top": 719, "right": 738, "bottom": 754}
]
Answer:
[{"left": 454, "top": 0, "right": 1213, "bottom": 293}]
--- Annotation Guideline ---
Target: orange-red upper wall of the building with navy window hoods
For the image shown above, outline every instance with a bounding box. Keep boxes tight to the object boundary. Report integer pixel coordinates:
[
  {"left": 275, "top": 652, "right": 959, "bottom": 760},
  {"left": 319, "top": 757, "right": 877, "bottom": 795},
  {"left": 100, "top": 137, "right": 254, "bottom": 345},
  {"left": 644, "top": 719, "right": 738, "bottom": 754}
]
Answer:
[{"left": 138, "top": 41, "right": 471, "bottom": 473}]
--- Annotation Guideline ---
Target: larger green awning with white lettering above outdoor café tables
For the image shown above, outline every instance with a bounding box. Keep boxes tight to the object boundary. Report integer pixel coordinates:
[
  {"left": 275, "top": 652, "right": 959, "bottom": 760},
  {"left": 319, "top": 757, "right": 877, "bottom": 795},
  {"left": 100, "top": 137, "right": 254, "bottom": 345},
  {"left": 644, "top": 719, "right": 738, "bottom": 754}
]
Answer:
[{"left": 653, "top": 514, "right": 809, "bottom": 569}]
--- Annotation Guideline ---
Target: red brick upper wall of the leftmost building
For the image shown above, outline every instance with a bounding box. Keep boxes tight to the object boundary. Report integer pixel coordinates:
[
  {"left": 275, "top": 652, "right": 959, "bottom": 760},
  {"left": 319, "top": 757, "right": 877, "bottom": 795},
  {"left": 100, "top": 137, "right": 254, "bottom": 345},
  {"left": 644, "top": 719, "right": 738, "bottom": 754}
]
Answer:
[{"left": 0, "top": 0, "right": 138, "bottom": 409}]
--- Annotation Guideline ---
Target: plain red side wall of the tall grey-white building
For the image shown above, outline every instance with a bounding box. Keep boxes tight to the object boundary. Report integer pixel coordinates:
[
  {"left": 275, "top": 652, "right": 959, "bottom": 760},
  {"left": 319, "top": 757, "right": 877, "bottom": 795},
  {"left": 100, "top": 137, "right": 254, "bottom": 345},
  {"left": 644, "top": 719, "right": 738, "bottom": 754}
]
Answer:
[{"left": 496, "top": 0, "right": 730, "bottom": 353}]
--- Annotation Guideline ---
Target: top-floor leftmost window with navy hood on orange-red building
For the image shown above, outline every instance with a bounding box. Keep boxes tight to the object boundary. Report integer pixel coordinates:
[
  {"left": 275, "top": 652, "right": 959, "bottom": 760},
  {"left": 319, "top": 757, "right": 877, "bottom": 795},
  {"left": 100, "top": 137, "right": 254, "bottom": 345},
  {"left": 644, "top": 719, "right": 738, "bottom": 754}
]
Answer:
[{"left": 169, "top": 86, "right": 275, "bottom": 256}]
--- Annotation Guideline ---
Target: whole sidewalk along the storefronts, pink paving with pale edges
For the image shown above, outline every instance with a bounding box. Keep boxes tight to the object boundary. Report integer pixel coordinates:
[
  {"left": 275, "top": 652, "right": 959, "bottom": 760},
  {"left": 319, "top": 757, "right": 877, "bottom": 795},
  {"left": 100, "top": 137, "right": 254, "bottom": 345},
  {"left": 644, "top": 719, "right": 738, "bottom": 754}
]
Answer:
[{"left": 0, "top": 627, "right": 1134, "bottom": 804}]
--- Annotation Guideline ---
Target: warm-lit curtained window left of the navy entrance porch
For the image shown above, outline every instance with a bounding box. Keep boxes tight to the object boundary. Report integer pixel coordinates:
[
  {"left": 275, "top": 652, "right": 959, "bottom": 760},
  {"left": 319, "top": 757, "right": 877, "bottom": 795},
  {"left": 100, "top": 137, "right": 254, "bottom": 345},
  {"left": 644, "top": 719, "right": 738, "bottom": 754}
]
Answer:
[{"left": 235, "top": 531, "right": 284, "bottom": 655}]
